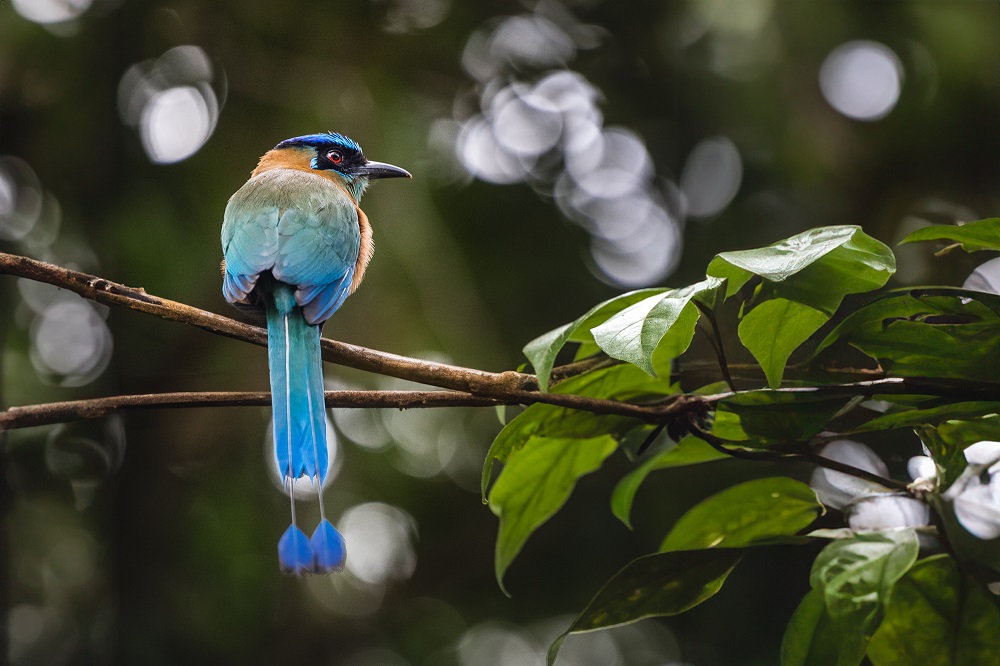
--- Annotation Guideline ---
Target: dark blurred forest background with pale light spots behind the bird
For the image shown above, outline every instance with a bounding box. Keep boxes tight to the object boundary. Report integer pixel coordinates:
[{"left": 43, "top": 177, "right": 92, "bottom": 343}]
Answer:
[{"left": 0, "top": 0, "right": 1000, "bottom": 666}]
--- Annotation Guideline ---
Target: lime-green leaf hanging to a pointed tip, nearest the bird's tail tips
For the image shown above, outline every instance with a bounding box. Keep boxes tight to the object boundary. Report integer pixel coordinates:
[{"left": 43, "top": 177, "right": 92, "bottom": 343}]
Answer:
[{"left": 490, "top": 435, "right": 618, "bottom": 588}]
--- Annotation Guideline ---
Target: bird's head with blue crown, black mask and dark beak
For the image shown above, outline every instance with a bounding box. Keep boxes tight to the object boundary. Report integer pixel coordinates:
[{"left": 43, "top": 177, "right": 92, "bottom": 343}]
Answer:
[{"left": 258, "top": 132, "right": 412, "bottom": 200}]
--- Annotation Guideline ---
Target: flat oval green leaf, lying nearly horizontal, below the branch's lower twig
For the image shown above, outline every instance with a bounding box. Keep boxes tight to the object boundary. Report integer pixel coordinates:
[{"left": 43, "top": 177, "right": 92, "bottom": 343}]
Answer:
[{"left": 660, "top": 476, "right": 823, "bottom": 552}]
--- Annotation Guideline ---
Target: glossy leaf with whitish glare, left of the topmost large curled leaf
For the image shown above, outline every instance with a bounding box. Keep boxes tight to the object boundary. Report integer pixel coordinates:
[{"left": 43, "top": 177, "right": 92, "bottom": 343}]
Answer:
[{"left": 591, "top": 278, "right": 724, "bottom": 375}]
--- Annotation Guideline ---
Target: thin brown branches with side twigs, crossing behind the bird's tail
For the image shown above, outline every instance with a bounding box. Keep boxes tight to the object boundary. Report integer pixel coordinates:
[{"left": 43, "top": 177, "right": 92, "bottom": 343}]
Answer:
[{"left": 0, "top": 253, "right": 1000, "bottom": 486}]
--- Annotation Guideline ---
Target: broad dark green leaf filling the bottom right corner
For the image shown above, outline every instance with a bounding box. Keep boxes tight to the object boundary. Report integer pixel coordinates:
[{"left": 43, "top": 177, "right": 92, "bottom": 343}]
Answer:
[{"left": 868, "top": 555, "right": 1000, "bottom": 666}]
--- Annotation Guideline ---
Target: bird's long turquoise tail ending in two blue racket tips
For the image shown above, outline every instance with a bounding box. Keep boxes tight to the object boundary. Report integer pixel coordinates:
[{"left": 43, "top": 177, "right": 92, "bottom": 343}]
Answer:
[{"left": 267, "top": 282, "right": 346, "bottom": 574}]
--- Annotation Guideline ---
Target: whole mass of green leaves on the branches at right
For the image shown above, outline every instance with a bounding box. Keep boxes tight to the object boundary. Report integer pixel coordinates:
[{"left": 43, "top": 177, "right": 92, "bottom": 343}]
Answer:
[{"left": 483, "top": 220, "right": 1000, "bottom": 666}]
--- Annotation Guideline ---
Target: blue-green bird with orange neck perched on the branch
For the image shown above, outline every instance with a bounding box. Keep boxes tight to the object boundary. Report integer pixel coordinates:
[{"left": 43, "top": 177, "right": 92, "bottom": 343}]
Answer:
[{"left": 222, "top": 132, "right": 412, "bottom": 575}]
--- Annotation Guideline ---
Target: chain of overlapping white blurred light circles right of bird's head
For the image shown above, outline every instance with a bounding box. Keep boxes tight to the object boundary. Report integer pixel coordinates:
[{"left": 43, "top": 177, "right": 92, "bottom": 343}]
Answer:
[{"left": 450, "top": 10, "right": 684, "bottom": 288}]
